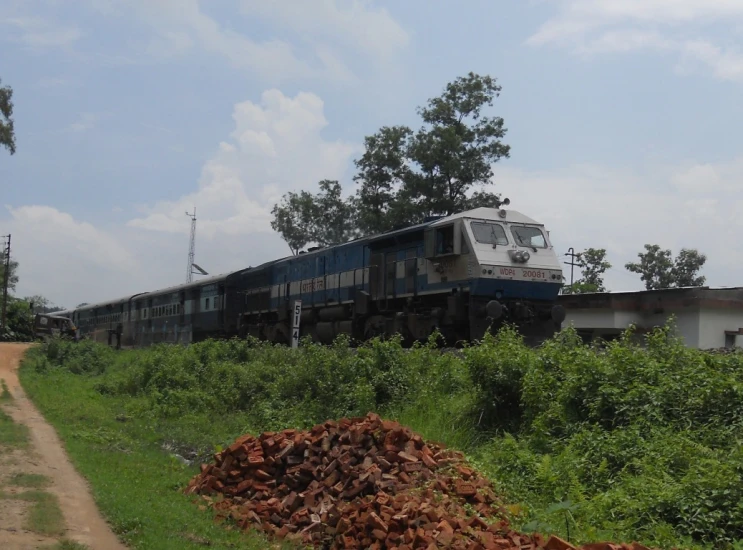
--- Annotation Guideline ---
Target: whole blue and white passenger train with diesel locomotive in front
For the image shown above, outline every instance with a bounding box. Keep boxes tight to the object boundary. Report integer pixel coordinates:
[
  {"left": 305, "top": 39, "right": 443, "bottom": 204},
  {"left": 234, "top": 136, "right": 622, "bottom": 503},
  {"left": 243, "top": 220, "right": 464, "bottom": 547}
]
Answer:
[{"left": 50, "top": 207, "right": 565, "bottom": 348}]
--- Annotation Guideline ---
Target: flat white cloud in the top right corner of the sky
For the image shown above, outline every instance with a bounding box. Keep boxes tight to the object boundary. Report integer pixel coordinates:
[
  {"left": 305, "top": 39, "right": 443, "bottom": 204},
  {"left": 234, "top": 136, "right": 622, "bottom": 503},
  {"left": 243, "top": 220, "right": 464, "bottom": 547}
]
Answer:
[{"left": 527, "top": 0, "right": 743, "bottom": 81}]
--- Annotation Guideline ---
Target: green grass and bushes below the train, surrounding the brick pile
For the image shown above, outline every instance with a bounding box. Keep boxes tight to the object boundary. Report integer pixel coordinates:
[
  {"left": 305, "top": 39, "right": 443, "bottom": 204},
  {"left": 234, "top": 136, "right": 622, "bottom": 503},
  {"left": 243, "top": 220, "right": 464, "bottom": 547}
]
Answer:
[{"left": 21, "top": 327, "right": 743, "bottom": 548}]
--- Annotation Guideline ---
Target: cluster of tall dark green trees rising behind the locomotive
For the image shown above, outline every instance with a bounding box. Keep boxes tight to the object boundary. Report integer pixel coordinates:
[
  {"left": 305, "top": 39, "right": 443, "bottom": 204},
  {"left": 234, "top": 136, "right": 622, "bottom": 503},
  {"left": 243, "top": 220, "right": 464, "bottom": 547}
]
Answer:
[{"left": 271, "top": 73, "right": 510, "bottom": 254}]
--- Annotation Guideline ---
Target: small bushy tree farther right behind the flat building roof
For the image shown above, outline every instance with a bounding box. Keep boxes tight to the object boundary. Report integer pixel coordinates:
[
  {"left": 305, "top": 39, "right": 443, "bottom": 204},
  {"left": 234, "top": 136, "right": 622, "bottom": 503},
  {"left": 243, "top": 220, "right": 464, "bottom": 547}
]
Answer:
[{"left": 625, "top": 244, "right": 707, "bottom": 290}]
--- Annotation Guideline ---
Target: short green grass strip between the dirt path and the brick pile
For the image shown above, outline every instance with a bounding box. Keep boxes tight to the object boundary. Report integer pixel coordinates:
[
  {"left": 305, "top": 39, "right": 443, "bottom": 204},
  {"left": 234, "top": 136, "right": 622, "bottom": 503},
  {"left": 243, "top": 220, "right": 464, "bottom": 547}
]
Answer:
[{"left": 20, "top": 354, "right": 296, "bottom": 550}]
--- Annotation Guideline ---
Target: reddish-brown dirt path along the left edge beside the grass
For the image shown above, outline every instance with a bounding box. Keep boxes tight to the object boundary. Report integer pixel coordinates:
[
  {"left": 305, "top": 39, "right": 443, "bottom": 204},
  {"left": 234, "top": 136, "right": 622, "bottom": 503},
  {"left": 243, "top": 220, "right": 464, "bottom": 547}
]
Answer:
[{"left": 0, "top": 343, "right": 126, "bottom": 550}]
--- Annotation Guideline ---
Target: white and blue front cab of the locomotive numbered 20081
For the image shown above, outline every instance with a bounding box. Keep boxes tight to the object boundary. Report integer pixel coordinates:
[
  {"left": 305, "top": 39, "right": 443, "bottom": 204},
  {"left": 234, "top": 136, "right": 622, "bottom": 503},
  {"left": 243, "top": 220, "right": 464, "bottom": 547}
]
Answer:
[{"left": 425, "top": 208, "right": 564, "bottom": 339}]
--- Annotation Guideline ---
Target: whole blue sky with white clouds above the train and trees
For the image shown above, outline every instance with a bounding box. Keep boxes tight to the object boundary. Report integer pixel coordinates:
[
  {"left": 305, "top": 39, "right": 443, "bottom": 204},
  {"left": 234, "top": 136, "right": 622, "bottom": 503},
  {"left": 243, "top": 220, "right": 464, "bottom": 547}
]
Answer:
[{"left": 0, "top": 0, "right": 743, "bottom": 307}]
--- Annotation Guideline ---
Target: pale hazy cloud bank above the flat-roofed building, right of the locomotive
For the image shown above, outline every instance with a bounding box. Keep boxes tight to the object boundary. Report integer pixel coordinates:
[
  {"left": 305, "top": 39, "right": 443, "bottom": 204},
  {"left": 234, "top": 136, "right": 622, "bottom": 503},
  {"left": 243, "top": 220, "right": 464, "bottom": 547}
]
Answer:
[{"left": 495, "top": 158, "right": 743, "bottom": 290}]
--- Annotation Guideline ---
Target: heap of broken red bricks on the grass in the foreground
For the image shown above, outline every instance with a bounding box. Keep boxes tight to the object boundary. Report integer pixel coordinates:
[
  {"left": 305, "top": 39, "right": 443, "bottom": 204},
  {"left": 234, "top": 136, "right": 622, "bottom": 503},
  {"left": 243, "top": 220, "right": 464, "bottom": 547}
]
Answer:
[{"left": 186, "top": 413, "right": 652, "bottom": 550}]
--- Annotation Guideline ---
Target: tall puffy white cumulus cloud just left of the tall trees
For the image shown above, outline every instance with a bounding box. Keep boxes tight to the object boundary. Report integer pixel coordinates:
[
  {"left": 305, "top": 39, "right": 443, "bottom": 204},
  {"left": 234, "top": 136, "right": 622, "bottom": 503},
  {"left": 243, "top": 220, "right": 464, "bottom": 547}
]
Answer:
[{"left": 129, "top": 90, "right": 357, "bottom": 239}]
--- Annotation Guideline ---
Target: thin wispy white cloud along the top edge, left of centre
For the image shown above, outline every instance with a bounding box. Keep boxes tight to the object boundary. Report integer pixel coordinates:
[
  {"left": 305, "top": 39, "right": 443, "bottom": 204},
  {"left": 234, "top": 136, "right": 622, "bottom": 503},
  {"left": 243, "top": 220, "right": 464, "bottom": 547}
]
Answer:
[{"left": 93, "top": 0, "right": 408, "bottom": 83}]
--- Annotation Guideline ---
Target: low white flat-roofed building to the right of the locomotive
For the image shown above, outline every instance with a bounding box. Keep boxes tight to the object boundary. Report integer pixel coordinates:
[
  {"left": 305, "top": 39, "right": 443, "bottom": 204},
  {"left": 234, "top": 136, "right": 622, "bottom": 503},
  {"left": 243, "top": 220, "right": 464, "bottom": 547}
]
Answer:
[{"left": 558, "top": 287, "right": 743, "bottom": 349}]
